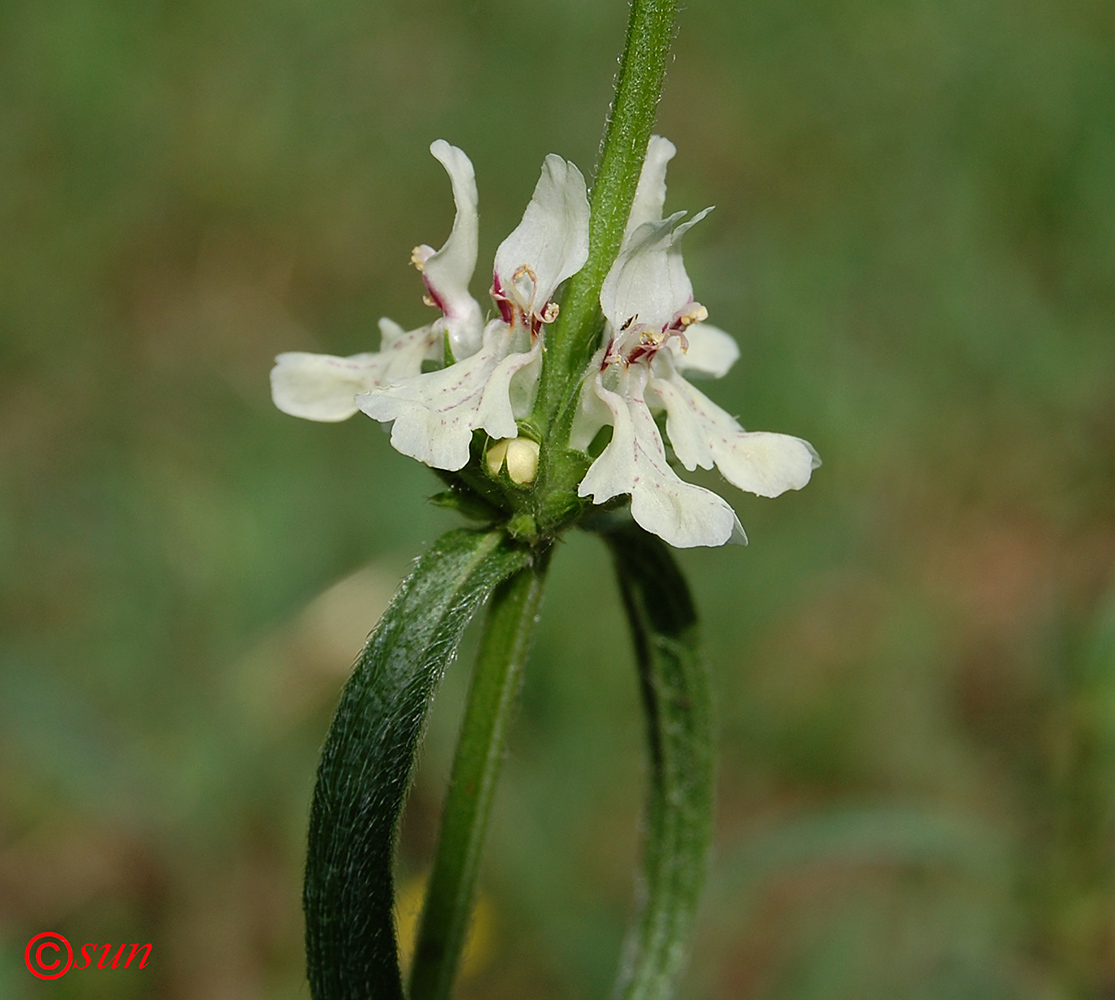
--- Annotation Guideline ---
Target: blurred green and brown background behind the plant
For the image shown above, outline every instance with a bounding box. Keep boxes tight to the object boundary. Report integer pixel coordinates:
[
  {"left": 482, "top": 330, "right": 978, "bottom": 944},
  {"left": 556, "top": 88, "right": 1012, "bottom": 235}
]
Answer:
[{"left": 0, "top": 0, "right": 1115, "bottom": 1000}]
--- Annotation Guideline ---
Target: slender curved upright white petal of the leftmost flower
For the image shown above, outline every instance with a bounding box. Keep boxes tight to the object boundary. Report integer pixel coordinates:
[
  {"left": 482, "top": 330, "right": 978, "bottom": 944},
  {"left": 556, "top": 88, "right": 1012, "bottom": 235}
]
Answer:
[{"left": 423, "top": 139, "right": 484, "bottom": 358}]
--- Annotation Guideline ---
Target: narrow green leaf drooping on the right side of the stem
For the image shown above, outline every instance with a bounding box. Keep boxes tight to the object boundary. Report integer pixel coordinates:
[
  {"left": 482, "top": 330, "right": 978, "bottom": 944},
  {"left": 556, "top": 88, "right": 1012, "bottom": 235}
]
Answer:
[{"left": 604, "top": 524, "right": 714, "bottom": 1000}]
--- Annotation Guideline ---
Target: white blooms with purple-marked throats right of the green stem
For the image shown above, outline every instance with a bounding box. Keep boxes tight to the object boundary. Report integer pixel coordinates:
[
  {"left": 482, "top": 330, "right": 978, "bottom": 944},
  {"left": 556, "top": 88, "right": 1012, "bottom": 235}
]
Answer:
[{"left": 571, "top": 136, "right": 821, "bottom": 548}]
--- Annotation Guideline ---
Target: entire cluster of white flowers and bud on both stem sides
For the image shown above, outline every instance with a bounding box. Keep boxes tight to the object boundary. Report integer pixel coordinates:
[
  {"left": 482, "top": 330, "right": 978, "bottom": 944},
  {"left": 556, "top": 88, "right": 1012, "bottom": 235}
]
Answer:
[{"left": 271, "top": 136, "right": 820, "bottom": 547}]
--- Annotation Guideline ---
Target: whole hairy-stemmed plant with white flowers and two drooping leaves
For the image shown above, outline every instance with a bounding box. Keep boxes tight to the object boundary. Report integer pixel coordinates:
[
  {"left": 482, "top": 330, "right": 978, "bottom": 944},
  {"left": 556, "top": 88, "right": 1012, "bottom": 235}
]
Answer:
[{"left": 271, "top": 0, "right": 818, "bottom": 1000}]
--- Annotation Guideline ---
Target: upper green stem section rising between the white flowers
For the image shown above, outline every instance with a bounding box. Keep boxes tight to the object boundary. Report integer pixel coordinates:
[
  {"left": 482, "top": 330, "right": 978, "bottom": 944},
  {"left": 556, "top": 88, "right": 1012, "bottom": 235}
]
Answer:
[{"left": 535, "top": 0, "right": 677, "bottom": 428}]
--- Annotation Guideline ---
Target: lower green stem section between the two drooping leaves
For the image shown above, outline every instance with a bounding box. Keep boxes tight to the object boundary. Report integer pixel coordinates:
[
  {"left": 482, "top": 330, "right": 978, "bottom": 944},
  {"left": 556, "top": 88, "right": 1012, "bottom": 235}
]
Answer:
[{"left": 410, "top": 553, "right": 549, "bottom": 1000}]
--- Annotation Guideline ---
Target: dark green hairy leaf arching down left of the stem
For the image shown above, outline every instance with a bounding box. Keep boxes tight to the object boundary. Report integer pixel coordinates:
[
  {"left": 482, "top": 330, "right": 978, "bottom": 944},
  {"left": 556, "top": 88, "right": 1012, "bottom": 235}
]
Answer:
[{"left": 303, "top": 531, "right": 531, "bottom": 1000}]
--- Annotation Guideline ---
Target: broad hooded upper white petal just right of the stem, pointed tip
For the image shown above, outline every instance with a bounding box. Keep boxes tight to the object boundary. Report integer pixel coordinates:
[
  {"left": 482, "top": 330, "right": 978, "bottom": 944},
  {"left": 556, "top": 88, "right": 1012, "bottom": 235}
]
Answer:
[{"left": 600, "top": 208, "right": 711, "bottom": 330}]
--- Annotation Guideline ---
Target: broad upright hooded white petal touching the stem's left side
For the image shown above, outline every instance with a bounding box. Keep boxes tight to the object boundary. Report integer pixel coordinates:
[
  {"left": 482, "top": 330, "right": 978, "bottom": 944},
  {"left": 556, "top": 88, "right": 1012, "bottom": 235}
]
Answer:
[{"left": 495, "top": 153, "right": 589, "bottom": 312}]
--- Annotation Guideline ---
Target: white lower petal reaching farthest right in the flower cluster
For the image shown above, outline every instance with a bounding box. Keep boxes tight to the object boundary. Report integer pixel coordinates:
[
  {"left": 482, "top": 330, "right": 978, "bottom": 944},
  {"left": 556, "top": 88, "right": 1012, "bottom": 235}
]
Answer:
[{"left": 650, "top": 376, "right": 821, "bottom": 496}]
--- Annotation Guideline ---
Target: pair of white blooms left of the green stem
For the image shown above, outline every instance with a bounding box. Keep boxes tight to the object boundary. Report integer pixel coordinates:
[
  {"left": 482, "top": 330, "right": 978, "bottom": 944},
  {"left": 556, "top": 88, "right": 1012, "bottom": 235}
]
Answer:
[{"left": 271, "top": 139, "right": 589, "bottom": 470}]
